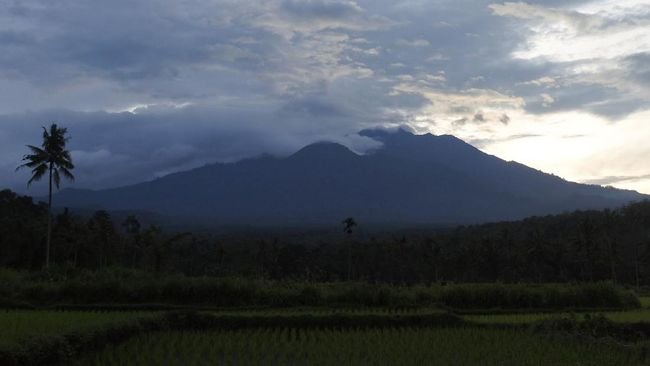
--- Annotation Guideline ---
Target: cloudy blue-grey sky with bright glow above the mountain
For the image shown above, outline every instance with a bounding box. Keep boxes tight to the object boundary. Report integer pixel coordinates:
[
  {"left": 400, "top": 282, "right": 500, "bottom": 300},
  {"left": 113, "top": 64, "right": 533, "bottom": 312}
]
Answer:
[{"left": 0, "top": 0, "right": 650, "bottom": 194}]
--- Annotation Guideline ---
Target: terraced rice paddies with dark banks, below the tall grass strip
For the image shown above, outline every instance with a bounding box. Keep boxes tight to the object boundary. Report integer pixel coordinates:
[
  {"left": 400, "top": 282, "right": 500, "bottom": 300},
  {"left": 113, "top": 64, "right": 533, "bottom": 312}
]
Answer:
[{"left": 0, "top": 309, "right": 650, "bottom": 365}]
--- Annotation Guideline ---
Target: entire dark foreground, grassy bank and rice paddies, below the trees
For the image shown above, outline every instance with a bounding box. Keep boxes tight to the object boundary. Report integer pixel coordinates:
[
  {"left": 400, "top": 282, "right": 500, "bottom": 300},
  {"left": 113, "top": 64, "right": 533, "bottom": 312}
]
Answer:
[{"left": 0, "top": 272, "right": 650, "bottom": 365}]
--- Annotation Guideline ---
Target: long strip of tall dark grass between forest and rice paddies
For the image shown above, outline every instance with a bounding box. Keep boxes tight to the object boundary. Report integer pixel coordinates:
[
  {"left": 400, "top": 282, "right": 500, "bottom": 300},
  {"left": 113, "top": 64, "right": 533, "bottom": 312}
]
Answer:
[{"left": 0, "top": 269, "right": 640, "bottom": 310}]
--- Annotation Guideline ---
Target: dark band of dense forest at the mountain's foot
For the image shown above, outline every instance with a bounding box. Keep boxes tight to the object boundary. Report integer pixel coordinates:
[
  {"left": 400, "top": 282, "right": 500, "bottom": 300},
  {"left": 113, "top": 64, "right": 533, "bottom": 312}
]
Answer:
[{"left": 0, "top": 190, "right": 650, "bottom": 286}]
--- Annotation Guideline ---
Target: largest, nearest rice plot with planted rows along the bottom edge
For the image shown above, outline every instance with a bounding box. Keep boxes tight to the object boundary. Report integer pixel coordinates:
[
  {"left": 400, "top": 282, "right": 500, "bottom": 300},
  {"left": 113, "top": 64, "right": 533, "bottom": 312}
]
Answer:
[{"left": 78, "top": 328, "right": 643, "bottom": 366}]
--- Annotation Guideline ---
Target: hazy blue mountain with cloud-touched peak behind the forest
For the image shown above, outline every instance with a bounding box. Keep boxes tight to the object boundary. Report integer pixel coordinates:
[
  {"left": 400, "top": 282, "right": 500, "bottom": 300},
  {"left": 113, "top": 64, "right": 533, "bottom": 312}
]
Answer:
[{"left": 55, "top": 130, "right": 646, "bottom": 225}]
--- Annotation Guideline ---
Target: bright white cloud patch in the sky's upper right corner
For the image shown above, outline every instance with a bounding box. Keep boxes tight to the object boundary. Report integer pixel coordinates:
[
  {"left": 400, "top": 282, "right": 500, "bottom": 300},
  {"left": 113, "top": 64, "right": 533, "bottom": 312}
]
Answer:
[{"left": 490, "top": 0, "right": 650, "bottom": 119}]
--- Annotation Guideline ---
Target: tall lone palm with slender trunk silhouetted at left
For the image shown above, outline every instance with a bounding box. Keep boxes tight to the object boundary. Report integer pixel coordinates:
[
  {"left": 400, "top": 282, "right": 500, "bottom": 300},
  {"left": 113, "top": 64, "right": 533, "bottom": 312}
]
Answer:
[{"left": 16, "top": 123, "right": 74, "bottom": 268}]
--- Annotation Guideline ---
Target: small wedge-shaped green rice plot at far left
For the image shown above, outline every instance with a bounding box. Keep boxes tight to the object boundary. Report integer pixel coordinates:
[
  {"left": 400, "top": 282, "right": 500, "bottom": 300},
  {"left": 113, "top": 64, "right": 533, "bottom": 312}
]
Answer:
[{"left": 0, "top": 310, "right": 150, "bottom": 346}]
